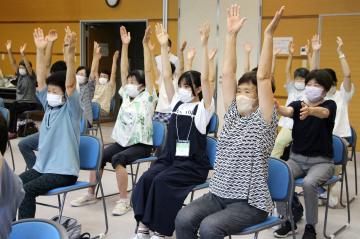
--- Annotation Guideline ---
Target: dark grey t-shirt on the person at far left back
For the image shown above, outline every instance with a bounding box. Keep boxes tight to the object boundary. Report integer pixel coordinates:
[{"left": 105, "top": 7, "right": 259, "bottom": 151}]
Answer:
[{"left": 16, "top": 74, "right": 37, "bottom": 103}]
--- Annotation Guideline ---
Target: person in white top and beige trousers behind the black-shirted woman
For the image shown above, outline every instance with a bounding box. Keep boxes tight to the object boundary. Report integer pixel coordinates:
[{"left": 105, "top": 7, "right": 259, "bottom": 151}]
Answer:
[{"left": 271, "top": 41, "right": 309, "bottom": 159}]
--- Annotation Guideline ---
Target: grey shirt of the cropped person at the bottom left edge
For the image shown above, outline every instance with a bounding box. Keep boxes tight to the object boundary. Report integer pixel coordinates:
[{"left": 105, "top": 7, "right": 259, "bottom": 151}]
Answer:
[{"left": 0, "top": 160, "right": 25, "bottom": 239}]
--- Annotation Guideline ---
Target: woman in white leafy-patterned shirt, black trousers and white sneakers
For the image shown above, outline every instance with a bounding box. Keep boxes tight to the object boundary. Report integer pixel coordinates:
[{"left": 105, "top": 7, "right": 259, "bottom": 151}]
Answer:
[{"left": 71, "top": 26, "right": 156, "bottom": 216}]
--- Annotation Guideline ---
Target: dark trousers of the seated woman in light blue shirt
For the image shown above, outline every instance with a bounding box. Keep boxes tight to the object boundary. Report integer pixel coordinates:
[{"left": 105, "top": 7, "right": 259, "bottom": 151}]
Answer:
[{"left": 19, "top": 169, "right": 77, "bottom": 219}]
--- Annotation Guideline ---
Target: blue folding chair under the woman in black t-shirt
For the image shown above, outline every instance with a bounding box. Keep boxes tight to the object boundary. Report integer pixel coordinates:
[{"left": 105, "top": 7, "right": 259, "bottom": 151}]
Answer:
[{"left": 295, "top": 135, "right": 350, "bottom": 238}]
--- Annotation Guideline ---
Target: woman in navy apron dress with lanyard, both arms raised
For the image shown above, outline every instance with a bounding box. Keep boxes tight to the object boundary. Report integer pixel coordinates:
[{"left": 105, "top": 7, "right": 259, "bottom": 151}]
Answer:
[{"left": 132, "top": 24, "right": 214, "bottom": 239}]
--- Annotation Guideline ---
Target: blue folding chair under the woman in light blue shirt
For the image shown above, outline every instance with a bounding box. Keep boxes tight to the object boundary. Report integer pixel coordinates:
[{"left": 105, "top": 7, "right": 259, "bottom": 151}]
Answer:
[{"left": 37, "top": 136, "right": 109, "bottom": 235}]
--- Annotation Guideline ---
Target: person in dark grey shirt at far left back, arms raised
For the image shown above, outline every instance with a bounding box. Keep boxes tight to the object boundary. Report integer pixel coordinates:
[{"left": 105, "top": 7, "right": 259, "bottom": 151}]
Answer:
[{"left": 6, "top": 40, "right": 38, "bottom": 139}]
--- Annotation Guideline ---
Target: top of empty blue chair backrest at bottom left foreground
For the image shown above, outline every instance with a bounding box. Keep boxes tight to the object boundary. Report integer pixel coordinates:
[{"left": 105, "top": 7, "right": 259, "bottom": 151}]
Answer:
[{"left": 9, "top": 219, "right": 69, "bottom": 239}]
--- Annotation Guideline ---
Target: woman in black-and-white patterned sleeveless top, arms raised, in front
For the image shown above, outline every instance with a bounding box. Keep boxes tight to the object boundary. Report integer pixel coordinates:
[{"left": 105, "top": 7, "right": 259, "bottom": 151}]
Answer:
[{"left": 175, "top": 4, "right": 284, "bottom": 239}]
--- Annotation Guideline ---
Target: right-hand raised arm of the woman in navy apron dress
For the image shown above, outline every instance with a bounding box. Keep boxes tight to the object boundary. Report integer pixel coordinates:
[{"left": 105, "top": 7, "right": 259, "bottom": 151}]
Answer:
[{"left": 200, "top": 23, "right": 214, "bottom": 109}]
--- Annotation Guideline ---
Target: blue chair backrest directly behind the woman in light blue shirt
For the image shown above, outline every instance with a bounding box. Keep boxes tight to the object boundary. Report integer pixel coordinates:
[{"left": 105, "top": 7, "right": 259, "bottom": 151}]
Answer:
[{"left": 79, "top": 135, "right": 103, "bottom": 170}]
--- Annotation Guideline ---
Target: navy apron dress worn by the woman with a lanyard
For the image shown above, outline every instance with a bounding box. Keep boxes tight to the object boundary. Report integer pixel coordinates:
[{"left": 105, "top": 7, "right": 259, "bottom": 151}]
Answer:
[{"left": 132, "top": 102, "right": 211, "bottom": 236}]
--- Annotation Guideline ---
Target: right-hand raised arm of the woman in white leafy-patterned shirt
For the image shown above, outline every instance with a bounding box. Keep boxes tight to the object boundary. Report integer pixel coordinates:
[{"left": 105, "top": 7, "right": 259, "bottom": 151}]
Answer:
[{"left": 143, "top": 26, "right": 154, "bottom": 95}]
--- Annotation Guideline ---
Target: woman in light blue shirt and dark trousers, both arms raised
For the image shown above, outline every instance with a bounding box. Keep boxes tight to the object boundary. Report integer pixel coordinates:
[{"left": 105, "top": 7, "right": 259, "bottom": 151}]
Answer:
[{"left": 18, "top": 28, "right": 82, "bottom": 219}]
